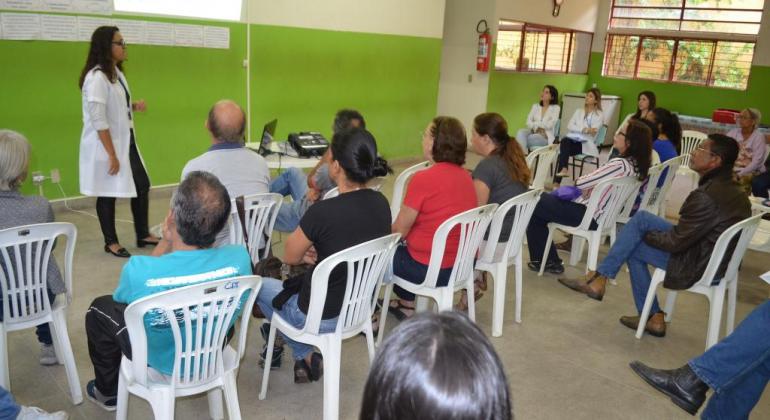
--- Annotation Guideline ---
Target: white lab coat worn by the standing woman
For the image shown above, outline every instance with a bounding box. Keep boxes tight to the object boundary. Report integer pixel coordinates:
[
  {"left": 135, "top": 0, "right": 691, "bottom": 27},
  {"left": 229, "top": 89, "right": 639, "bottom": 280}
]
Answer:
[{"left": 80, "top": 67, "right": 144, "bottom": 197}]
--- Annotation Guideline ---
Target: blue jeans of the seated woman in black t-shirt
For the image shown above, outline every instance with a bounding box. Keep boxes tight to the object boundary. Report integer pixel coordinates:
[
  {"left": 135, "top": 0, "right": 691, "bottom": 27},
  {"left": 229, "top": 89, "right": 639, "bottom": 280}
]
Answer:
[{"left": 257, "top": 277, "right": 337, "bottom": 360}]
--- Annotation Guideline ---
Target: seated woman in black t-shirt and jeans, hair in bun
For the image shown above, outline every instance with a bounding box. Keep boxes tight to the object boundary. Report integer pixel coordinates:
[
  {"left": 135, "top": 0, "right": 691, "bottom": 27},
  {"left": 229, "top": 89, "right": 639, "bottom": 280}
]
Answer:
[{"left": 257, "top": 128, "right": 391, "bottom": 383}]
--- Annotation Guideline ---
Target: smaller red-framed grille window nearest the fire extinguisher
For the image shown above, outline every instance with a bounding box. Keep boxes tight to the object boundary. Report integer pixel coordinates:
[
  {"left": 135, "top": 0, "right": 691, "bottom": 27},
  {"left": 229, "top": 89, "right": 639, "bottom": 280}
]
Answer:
[{"left": 495, "top": 20, "right": 594, "bottom": 74}]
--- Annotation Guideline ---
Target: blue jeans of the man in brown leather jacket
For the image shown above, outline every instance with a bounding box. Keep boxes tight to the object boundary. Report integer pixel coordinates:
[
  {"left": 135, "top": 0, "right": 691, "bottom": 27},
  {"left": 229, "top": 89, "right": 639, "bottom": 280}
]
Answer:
[{"left": 596, "top": 211, "right": 674, "bottom": 314}]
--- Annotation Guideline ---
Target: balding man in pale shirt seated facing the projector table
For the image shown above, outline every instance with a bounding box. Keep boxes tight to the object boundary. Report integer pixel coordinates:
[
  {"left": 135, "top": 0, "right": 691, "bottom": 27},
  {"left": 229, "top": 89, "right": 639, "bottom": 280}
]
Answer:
[{"left": 182, "top": 100, "right": 270, "bottom": 246}]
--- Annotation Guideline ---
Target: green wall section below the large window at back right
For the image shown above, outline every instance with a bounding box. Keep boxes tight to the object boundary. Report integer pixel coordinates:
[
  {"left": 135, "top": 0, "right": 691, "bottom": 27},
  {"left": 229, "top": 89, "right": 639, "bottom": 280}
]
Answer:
[{"left": 586, "top": 53, "right": 770, "bottom": 118}]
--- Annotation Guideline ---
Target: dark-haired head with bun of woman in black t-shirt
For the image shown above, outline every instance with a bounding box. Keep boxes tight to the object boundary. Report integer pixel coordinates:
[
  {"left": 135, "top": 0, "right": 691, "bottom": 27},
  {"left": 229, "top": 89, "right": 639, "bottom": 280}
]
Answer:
[{"left": 331, "top": 128, "right": 393, "bottom": 184}]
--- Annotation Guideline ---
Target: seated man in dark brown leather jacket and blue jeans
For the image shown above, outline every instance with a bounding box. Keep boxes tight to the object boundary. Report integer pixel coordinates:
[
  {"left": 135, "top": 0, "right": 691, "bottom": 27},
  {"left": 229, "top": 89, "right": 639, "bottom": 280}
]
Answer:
[{"left": 559, "top": 134, "right": 751, "bottom": 337}]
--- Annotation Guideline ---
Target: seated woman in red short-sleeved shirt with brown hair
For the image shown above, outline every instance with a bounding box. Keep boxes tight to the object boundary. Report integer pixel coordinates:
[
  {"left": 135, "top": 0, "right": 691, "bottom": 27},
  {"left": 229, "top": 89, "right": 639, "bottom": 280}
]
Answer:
[{"left": 382, "top": 117, "right": 477, "bottom": 322}]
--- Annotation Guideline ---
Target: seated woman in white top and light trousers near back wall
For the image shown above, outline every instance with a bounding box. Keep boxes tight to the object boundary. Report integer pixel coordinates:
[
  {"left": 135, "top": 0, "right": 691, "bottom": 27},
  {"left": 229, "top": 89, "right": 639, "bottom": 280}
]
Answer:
[{"left": 516, "top": 85, "right": 561, "bottom": 153}]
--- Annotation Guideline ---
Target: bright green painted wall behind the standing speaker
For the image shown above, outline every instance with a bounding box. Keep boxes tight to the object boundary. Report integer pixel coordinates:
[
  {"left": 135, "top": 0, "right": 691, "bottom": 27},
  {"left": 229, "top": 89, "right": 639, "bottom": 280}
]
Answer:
[{"left": 0, "top": 16, "right": 441, "bottom": 199}]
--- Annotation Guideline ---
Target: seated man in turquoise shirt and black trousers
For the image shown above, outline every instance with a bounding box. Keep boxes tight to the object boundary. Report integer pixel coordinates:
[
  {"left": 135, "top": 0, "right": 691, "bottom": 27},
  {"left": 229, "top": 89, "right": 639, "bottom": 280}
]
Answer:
[{"left": 86, "top": 172, "right": 251, "bottom": 411}]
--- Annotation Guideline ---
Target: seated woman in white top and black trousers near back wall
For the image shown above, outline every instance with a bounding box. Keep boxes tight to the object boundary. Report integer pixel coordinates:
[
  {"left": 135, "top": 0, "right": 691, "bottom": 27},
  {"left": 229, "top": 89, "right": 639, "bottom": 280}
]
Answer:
[{"left": 554, "top": 88, "right": 604, "bottom": 184}]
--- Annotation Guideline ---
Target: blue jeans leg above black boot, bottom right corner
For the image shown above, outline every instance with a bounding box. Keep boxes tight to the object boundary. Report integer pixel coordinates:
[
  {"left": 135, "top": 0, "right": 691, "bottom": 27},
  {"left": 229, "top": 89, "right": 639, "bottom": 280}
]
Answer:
[{"left": 688, "top": 300, "right": 770, "bottom": 419}]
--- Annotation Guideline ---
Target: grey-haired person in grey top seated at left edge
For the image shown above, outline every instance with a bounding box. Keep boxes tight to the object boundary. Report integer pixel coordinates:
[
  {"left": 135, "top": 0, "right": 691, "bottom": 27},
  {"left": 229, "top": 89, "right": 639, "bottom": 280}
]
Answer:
[{"left": 0, "top": 130, "right": 65, "bottom": 366}]
